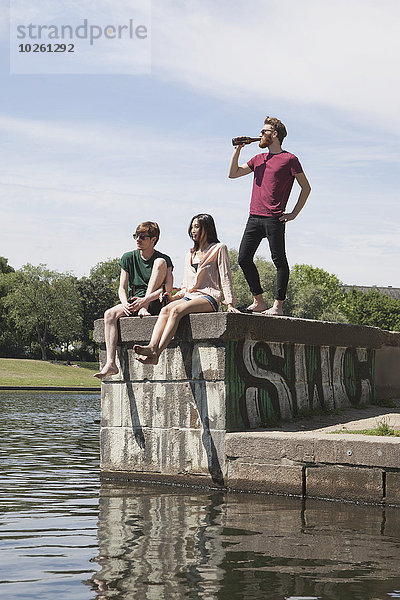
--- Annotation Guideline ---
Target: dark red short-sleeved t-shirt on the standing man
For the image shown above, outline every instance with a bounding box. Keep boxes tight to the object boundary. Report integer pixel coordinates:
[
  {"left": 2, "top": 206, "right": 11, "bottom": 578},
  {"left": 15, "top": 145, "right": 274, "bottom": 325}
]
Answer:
[{"left": 247, "top": 150, "right": 303, "bottom": 217}]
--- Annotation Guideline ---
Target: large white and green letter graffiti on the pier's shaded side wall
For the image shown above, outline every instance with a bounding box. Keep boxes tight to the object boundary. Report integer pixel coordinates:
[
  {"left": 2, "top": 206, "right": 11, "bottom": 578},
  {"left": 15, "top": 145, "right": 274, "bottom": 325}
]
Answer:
[{"left": 226, "top": 340, "right": 375, "bottom": 431}]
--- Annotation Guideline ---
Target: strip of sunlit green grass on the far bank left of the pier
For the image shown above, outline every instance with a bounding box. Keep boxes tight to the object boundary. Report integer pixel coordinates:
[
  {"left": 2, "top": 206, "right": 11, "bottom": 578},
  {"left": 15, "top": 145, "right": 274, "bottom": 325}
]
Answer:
[{"left": 0, "top": 358, "right": 100, "bottom": 388}]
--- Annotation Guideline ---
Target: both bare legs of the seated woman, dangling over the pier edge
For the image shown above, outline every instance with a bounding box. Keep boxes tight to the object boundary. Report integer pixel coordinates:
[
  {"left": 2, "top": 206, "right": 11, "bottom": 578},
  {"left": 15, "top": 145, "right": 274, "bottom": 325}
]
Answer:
[{"left": 134, "top": 298, "right": 213, "bottom": 365}]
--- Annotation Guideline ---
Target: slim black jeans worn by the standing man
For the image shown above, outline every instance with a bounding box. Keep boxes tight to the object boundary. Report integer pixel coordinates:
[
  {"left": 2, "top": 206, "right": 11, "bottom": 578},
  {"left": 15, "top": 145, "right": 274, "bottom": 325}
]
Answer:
[{"left": 238, "top": 215, "right": 289, "bottom": 300}]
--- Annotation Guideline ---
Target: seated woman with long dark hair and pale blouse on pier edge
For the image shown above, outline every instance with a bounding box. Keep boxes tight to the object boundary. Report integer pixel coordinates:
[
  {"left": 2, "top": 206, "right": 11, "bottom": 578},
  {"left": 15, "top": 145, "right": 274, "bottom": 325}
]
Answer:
[{"left": 133, "top": 214, "right": 239, "bottom": 365}]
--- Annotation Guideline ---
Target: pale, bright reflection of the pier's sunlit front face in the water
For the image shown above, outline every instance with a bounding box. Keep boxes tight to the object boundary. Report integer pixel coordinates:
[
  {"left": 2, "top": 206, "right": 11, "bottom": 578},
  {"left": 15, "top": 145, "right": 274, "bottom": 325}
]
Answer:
[{"left": 92, "top": 485, "right": 224, "bottom": 600}]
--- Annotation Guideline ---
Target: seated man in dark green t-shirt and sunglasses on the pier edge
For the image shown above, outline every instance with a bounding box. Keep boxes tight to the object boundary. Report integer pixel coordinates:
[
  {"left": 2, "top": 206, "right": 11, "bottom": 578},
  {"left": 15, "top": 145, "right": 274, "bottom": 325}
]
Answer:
[{"left": 94, "top": 221, "right": 174, "bottom": 379}]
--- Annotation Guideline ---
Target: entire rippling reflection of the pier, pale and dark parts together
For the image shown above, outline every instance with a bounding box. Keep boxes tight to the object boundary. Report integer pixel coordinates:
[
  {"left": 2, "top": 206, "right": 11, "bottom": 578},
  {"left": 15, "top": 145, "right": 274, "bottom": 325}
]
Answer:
[{"left": 91, "top": 484, "right": 400, "bottom": 600}]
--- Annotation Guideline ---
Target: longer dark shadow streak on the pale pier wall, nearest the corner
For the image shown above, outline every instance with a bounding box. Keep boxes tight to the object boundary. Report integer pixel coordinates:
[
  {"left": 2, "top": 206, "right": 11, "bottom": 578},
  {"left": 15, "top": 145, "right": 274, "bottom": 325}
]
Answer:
[{"left": 178, "top": 316, "right": 225, "bottom": 485}]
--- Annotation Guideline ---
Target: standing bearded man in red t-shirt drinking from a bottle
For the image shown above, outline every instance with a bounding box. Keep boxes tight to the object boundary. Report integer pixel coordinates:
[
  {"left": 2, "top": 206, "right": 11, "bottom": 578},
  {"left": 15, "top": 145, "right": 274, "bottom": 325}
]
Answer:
[{"left": 229, "top": 117, "right": 311, "bottom": 315}]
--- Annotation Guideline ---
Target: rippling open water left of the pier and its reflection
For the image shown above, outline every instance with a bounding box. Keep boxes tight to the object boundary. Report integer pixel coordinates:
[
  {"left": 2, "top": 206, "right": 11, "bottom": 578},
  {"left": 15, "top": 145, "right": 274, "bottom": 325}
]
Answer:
[{"left": 0, "top": 392, "right": 99, "bottom": 600}]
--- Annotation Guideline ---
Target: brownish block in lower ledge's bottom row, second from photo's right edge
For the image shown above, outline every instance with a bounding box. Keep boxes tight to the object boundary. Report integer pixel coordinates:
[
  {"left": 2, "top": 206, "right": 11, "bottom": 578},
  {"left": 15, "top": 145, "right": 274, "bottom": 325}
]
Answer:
[{"left": 306, "top": 465, "right": 383, "bottom": 502}]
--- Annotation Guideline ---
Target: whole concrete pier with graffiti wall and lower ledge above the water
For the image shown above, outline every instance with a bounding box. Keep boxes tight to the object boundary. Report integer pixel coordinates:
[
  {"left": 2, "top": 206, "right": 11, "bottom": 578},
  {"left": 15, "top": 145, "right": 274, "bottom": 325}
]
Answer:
[{"left": 95, "top": 313, "right": 400, "bottom": 503}]
